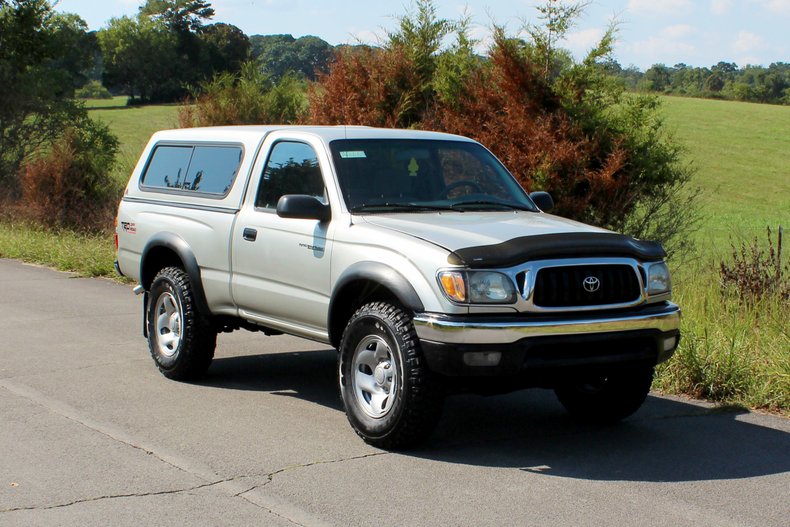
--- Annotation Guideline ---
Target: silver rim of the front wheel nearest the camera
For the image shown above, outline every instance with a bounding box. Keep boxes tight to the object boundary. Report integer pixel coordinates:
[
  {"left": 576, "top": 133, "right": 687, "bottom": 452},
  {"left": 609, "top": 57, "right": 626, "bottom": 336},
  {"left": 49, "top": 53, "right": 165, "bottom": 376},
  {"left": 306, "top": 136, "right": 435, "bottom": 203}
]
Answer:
[{"left": 351, "top": 335, "right": 398, "bottom": 419}]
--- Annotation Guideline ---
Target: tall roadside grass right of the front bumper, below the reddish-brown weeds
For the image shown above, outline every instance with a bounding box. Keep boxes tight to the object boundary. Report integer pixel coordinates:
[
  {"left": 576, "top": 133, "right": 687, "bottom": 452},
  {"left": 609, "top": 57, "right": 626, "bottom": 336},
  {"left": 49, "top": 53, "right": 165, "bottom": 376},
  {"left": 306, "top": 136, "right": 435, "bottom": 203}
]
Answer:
[{"left": 655, "top": 260, "right": 790, "bottom": 415}]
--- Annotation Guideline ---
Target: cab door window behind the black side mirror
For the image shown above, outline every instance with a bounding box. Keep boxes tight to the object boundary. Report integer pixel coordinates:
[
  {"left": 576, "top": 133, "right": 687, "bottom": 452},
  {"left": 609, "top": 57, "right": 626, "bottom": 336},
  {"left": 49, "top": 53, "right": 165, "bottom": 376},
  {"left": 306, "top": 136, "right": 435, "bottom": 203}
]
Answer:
[{"left": 255, "top": 141, "right": 326, "bottom": 209}]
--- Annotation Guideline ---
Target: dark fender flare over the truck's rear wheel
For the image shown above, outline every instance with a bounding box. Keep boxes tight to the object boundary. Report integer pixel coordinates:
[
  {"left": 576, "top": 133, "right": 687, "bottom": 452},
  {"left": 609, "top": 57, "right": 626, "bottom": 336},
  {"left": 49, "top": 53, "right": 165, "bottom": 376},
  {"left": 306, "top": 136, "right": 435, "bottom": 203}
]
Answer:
[{"left": 140, "top": 232, "right": 210, "bottom": 315}]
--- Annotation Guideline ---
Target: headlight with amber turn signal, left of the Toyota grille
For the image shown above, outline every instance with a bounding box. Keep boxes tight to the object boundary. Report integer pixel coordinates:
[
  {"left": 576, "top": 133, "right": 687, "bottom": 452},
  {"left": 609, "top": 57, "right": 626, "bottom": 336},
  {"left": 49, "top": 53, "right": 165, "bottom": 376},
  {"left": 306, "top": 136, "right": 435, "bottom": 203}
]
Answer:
[{"left": 439, "top": 271, "right": 516, "bottom": 304}]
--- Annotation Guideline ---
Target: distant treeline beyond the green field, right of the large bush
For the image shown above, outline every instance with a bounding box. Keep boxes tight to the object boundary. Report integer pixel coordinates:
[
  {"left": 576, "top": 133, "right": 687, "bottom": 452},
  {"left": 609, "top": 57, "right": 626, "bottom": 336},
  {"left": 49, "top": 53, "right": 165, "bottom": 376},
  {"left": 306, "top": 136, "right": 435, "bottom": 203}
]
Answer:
[{"left": 606, "top": 61, "right": 790, "bottom": 104}]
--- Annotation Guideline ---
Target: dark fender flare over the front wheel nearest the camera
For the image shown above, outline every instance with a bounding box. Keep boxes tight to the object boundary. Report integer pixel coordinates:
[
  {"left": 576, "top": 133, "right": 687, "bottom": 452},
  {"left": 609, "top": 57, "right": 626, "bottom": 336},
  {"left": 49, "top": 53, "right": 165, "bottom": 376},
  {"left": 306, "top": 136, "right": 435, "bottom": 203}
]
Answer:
[{"left": 327, "top": 262, "right": 425, "bottom": 348}]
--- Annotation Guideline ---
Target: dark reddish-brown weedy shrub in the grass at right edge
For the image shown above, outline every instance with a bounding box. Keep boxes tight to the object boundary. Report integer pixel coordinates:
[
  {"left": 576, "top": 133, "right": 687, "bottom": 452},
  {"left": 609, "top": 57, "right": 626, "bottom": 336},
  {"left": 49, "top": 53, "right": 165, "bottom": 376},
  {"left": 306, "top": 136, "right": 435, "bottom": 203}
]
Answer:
[{"left": 719, "top": 226, "right": 790, "bottom": 304}]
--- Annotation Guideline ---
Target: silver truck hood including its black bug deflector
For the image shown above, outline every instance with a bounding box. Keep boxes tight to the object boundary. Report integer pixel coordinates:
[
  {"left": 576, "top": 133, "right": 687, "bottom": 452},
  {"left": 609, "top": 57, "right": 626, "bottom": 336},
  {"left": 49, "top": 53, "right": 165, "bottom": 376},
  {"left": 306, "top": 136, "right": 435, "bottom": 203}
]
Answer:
[{"left": 364, "top": 211, "right": 666, "bottom": 268}]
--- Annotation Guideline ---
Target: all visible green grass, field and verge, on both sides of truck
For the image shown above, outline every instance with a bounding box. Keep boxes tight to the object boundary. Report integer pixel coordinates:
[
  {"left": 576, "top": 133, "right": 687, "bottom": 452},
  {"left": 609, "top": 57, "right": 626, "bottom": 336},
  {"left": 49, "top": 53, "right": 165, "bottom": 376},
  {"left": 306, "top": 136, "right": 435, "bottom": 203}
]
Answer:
[{"left": 0, "top": 97, "right": 790, "bottom": 415}]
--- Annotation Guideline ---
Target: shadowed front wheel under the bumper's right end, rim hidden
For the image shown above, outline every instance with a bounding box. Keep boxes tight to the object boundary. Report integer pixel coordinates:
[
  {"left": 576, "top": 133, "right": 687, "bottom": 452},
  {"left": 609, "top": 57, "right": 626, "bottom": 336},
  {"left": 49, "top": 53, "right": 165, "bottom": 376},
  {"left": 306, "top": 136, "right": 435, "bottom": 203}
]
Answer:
[{"left": 554, "top": 366, "right": 653, "bottom": 423}]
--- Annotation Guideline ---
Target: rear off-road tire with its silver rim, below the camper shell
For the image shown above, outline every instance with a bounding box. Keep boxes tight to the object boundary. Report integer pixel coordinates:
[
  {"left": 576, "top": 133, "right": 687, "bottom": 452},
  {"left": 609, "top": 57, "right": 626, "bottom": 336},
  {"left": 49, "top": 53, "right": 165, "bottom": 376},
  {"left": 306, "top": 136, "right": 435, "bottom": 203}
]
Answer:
[{"left": 146, "top": 267, "right": 217, "bottom": 381}]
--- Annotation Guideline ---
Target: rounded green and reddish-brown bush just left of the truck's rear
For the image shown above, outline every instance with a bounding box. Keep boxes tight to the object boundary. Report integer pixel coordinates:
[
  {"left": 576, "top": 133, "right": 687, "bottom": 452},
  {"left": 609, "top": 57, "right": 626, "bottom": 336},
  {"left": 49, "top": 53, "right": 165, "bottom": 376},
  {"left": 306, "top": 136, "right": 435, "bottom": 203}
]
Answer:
[{"left": 15, "top": 117, "right": 122, "bottom": 231}]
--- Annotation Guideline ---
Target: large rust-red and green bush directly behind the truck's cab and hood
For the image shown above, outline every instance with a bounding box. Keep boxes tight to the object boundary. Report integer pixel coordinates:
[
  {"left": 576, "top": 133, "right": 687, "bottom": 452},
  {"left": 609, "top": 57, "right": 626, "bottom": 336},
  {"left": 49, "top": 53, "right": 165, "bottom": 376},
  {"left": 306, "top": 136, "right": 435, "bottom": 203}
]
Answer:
[{"left": 308, "top": 0, "right": 697, "bottom": 254}]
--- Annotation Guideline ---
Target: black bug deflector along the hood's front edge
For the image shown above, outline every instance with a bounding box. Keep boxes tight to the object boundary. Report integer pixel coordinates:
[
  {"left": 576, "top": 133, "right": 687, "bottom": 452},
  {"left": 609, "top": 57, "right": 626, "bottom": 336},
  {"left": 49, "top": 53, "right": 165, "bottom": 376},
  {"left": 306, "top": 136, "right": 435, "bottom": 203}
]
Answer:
[{"left": 447, "top": 232, "right": 667, "bottom": 268}]
